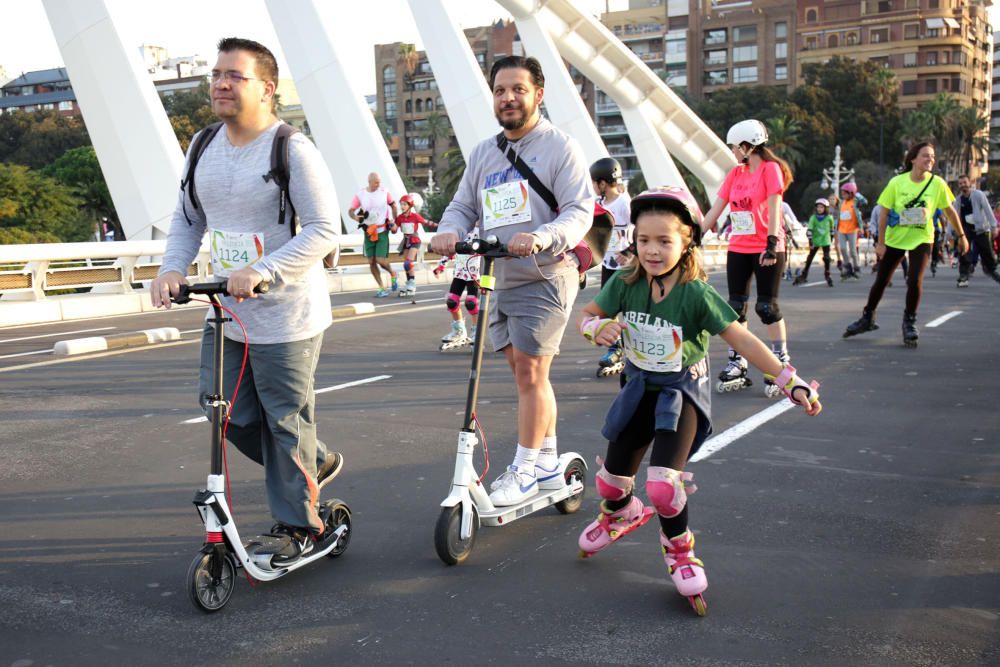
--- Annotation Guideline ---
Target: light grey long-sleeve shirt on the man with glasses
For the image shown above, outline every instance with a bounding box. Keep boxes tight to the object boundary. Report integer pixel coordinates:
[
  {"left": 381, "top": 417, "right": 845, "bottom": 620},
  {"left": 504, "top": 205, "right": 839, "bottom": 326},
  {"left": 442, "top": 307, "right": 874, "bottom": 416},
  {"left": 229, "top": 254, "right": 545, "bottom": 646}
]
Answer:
[{"left": 160, "top": 123, "right": 340, "bottom": 343}]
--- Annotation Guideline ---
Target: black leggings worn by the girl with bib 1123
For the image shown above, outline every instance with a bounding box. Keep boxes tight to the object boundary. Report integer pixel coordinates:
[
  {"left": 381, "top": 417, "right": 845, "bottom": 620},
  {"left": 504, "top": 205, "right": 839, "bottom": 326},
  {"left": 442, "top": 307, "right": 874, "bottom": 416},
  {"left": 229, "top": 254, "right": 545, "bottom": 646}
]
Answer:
[{"left": 604, "top": 391, "right": 698, "bottom": 537}]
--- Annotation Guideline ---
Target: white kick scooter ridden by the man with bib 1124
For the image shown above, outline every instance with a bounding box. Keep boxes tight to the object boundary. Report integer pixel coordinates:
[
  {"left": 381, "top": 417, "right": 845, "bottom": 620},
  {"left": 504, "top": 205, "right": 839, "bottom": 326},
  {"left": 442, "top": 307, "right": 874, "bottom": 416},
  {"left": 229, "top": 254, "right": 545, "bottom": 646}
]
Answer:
[{"left": 172, "top": 282, "right": 351, "bottom": 613}]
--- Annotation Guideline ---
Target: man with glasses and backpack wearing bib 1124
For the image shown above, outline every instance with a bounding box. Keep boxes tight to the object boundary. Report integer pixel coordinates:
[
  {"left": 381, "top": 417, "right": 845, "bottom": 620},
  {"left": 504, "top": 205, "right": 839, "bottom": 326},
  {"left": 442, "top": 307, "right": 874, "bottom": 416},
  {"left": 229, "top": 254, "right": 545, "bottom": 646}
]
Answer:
[{"left": 150, "top": 38, "right": 343, "bottom": 563}]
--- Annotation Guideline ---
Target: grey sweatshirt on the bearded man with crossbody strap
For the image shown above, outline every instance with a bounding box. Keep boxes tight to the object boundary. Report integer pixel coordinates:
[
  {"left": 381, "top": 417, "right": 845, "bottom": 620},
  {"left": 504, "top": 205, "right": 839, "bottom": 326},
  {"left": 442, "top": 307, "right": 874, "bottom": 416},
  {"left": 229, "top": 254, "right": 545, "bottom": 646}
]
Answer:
[{"left": 438, "top": 118, "right": 594, "bottom": 289}]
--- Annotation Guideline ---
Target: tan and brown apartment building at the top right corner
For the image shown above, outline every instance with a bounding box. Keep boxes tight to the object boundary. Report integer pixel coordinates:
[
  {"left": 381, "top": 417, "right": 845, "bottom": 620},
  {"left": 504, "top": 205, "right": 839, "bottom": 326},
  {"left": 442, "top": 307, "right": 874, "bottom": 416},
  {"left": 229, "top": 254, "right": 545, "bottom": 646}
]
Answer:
[{"left": 795, "top": 0, "right": 993, "bottom": 113}]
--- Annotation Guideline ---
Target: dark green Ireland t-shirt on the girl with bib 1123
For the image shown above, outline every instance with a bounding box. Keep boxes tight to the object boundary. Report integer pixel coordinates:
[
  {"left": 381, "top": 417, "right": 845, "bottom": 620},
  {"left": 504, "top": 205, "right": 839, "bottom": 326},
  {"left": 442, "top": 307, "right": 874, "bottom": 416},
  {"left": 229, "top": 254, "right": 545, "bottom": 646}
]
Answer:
[{"left": 594, "top": 271, "right": 738, "bottom": 368}]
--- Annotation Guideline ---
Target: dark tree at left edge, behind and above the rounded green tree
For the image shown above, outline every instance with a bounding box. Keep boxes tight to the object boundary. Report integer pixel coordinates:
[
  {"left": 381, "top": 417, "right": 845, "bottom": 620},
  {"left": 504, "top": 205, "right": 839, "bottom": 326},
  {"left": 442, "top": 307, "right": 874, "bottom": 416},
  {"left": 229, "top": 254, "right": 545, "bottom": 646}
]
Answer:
[{"left": 0, "top": 111, "right": 90, "bottom": 169}]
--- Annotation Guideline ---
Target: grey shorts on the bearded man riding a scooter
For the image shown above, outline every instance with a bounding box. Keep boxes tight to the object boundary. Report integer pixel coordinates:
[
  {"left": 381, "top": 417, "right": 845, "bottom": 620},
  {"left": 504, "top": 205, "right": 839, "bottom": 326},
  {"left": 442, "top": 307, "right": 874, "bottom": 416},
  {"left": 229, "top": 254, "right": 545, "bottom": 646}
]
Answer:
[{"left": 489, "top": 273, "right": 580, "bottom": 357}]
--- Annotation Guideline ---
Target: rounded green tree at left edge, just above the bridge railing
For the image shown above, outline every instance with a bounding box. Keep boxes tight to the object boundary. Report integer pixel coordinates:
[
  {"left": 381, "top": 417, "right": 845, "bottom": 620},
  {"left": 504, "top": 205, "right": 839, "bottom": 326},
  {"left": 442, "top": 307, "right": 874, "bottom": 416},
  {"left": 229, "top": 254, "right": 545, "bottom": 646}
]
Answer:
[{"left": 0, "top": 163, "right": 93, "bottom": 242}]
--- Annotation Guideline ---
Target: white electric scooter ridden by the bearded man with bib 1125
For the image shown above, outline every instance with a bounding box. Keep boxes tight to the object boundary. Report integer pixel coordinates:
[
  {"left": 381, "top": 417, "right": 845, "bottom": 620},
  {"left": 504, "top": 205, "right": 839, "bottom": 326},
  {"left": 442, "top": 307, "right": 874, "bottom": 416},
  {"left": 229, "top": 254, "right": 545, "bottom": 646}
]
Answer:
[{"left": 434, "top": 236, "right": 587, "bottom": 565}]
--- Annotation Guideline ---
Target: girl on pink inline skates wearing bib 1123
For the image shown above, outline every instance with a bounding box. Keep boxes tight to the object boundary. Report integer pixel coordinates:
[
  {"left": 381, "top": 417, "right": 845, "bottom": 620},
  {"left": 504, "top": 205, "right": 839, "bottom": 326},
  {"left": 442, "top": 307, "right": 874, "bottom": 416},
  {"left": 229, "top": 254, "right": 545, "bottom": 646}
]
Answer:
[{"left": 579, "top": 187, "right": 822, "bottom": 615}]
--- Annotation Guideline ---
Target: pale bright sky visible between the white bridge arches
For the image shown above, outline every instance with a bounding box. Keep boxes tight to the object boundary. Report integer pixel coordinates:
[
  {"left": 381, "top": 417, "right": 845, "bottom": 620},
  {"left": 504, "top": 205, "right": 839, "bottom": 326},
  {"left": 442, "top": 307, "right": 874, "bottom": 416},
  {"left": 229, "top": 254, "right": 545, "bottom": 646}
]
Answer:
[{"left": 0, "top": 0, "right": 627, "bottom": 95}]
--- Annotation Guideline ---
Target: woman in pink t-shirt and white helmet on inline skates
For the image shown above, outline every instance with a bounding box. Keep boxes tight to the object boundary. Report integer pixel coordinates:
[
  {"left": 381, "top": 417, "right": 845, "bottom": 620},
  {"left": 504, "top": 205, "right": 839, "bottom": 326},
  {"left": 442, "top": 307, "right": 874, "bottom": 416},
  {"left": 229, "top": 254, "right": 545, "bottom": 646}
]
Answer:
[{"left": 702, "top": 120, "right": 792, "bottom": 398}]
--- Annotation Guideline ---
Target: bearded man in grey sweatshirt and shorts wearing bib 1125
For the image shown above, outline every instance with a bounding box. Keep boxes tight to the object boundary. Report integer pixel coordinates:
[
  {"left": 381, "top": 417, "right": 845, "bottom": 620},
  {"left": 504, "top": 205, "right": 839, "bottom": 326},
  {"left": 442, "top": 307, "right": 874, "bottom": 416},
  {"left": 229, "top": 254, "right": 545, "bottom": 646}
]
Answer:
[{"left": 431, "top": 56, "right": 594, "bottom": 506}]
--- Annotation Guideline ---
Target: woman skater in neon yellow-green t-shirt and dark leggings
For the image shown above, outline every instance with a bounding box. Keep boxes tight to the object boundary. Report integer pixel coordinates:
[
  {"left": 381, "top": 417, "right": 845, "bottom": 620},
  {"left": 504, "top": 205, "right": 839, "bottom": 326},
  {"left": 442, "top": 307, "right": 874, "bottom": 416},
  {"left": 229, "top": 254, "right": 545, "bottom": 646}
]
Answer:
[{"left": 844, "top": 142, "right": 969, "bottom": 347}]
